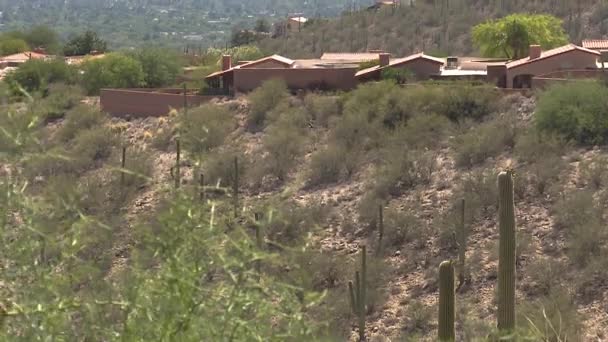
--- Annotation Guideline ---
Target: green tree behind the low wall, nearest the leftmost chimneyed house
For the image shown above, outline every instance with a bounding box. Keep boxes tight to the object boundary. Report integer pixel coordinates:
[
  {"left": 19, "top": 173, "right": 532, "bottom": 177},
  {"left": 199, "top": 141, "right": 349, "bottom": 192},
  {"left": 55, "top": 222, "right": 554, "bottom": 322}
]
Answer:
[{"left": 131, "top": 47, "right": 181, "bottom": 88}]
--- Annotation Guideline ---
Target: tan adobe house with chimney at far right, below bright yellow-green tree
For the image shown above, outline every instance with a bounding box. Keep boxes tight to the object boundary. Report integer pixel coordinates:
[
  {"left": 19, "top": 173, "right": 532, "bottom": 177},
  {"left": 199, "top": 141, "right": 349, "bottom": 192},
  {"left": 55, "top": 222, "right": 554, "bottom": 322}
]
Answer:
[{"left": 487, "top": 44, "right": 600, "bottom": 88}]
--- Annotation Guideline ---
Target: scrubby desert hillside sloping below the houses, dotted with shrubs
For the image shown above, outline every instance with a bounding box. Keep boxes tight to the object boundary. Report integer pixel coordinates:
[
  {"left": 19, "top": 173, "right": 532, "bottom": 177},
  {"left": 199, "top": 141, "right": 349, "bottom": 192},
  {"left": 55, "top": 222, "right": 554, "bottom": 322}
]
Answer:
[{"left": 0, "top": 82, "right": 608, "bottom": 341}]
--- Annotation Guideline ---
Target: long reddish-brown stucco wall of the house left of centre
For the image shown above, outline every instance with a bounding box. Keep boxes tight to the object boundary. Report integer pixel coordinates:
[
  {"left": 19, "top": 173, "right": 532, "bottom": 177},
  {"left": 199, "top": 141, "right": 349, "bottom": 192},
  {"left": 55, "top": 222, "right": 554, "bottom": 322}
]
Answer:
[{"left": 234, "top": 68, "right": 357, "bottom": 92}]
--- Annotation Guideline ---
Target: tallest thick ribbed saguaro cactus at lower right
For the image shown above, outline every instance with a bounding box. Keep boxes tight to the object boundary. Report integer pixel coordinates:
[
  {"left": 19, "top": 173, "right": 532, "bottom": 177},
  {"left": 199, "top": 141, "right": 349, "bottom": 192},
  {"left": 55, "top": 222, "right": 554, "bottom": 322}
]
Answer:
[{"left": 496, "top": 171, "right": 516, "bottom": 332}]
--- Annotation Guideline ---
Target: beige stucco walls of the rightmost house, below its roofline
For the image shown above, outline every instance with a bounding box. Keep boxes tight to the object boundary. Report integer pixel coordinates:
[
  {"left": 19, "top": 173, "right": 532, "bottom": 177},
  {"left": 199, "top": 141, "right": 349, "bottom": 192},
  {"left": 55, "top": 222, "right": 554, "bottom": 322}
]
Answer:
[{"left": 506, "top": 50, "right": 600, "bottom": 88}]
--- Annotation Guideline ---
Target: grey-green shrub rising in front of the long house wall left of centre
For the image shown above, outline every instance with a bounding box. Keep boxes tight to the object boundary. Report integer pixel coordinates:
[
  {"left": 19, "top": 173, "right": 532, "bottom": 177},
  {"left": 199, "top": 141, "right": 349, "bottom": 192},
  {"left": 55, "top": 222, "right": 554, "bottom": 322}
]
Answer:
[{"left": 247, "top": 80, "right": 289, "bottom": 130}]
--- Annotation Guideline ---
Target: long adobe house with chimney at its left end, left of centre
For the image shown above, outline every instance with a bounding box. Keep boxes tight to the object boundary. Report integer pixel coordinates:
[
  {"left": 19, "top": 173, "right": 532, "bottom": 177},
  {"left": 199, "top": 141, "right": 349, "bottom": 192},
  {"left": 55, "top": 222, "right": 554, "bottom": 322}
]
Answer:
[{"left": 205, "top": 55, "right": 358, "bottom": 94}]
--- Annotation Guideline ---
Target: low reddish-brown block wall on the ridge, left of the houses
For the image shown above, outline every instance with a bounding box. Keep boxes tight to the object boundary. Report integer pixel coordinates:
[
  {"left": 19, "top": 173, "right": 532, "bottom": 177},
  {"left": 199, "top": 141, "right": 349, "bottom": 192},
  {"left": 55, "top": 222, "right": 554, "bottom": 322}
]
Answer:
[{"left": 99, "top": 89, "right": 216, "bottom": 117}]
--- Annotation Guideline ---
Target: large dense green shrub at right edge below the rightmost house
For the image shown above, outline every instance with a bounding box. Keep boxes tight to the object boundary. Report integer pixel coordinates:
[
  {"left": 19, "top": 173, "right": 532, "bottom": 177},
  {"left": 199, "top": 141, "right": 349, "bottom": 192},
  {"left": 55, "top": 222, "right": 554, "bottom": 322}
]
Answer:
[{"left": 535, "top": 81, "right": 608, "bottom": 145}]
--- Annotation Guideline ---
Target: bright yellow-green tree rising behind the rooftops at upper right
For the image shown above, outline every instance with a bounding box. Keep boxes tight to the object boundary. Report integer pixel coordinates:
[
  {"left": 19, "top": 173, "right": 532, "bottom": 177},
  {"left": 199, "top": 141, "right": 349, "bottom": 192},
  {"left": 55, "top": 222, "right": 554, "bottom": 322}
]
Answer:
[{"left": 472, "top": 14, "right": 568, "bottom": 59}]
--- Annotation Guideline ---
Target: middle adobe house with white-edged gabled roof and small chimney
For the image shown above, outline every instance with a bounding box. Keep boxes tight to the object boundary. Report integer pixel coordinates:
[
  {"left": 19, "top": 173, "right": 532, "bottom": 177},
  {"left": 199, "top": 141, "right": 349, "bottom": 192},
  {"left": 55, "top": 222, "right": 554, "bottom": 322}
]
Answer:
[{"left": 355, "top": 52, "right": 445, "bottom": 82}]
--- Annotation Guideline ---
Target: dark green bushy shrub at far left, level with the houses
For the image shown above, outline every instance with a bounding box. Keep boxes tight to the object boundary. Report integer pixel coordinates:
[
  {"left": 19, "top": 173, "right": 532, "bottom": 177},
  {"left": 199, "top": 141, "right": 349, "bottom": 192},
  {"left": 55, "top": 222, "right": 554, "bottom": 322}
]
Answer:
[{"left": 6, "top": 59, "right": 77, "bottom": 95}]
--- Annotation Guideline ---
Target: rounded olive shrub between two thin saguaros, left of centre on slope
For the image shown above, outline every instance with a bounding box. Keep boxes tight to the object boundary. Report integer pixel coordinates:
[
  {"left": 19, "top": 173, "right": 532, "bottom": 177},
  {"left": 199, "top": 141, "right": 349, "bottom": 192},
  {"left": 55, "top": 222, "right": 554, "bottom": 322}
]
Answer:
[{"left": 203, "top": 149, "right": 248, "bottom": 187}]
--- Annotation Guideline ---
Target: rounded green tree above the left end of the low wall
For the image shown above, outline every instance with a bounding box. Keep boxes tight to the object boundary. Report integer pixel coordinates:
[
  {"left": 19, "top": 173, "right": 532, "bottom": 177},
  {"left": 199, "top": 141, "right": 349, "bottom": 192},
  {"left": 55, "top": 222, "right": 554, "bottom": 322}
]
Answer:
[{"left": 82, "top": 53, "right": 145, "bottom": 95}]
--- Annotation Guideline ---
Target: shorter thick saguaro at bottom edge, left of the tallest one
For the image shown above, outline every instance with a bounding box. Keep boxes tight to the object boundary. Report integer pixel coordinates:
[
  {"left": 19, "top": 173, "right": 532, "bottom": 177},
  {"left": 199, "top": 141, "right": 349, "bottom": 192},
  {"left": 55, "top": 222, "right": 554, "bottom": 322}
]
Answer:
[{"left": 439, "top": 261, "right": 456, "bottom": 342}]
